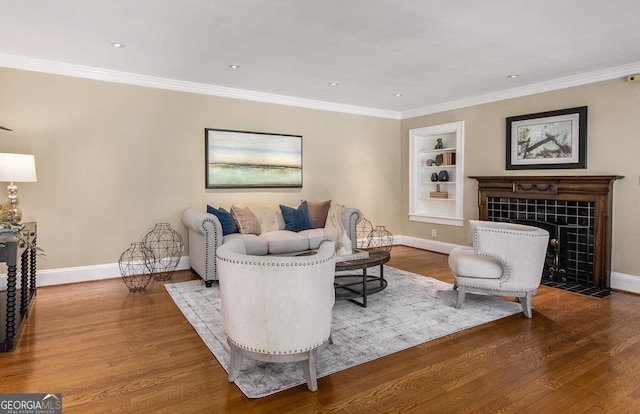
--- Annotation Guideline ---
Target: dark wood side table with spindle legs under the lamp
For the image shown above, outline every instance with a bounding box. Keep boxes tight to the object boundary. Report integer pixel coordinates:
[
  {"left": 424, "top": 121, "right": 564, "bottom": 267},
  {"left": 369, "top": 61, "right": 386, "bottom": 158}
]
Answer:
[{"left": 0, "top": 222, "right": 37, "bottom": 352}]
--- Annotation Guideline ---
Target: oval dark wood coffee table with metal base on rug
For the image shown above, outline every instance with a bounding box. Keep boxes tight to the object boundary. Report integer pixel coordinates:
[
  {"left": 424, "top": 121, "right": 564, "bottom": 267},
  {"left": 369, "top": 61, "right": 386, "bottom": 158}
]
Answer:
[{"left": 333, "top": 249, "right": 391, "bottom": 308}]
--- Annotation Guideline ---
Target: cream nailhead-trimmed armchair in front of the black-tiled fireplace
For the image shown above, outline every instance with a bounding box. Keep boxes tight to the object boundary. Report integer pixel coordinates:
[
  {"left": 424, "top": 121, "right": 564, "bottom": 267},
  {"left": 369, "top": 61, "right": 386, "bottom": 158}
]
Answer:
[{"left": 449, "top": 220, "right": 549, "bottom": 318}]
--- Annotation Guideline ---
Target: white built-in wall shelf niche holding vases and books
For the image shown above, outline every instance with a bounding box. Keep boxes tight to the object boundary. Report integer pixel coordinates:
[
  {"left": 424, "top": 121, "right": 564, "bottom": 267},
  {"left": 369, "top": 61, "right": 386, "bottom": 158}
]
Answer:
[{"left": 409, "top": 121, "right": 464, "bottom": 226}]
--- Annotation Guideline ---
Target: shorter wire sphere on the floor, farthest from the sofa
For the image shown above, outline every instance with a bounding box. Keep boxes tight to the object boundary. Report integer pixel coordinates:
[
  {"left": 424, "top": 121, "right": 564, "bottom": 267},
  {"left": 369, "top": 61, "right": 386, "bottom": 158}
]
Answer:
[{"left": 118, "top": 242, "right": 153, "bottom": 292}]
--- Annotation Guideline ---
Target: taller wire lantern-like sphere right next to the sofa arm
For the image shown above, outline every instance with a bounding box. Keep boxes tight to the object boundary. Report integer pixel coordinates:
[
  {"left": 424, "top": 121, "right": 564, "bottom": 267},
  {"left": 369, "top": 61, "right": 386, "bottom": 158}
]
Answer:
[{"left": 142, "top": 223, "right": 183, "bottom": 280}]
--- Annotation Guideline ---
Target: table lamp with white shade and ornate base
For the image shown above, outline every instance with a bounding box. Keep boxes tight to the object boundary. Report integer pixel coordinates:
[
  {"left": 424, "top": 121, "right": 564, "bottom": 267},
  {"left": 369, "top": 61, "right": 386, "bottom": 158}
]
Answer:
[{"left": 0, "top": 153, "right": 37, "bottom": 223}]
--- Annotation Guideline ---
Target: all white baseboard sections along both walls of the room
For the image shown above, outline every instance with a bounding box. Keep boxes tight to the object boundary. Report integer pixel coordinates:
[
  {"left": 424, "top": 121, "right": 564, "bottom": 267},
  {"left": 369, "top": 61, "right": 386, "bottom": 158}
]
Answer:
[{"left": 0, "top": 236, "right": 640, "bottom": 294}]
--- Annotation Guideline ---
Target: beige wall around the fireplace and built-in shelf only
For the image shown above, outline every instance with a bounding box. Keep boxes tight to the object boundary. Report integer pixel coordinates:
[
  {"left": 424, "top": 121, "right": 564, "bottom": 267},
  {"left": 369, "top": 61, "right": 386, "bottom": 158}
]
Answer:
[{"left": 401, "top": 79, "right": 640, "bottom": 275}]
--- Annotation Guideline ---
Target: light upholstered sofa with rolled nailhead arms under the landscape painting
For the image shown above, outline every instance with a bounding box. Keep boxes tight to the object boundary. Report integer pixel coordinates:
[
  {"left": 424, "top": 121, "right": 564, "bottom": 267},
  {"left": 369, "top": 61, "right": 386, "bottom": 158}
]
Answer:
[{"left": 182, "top": 206, "right": 361, "bottom": 287}]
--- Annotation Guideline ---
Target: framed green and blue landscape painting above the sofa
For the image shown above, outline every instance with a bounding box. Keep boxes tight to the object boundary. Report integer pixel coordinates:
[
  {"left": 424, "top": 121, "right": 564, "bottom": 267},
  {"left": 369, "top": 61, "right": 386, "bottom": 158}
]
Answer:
[{"left": 204, "top": 128, "right": 302, "bottom": 188}]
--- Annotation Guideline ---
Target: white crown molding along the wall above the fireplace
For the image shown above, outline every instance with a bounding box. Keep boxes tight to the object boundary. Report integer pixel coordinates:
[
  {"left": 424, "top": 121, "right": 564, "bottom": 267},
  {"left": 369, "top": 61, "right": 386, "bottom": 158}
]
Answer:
[{"left": 400, "top": 62, "right": 640, "bottom": 119}]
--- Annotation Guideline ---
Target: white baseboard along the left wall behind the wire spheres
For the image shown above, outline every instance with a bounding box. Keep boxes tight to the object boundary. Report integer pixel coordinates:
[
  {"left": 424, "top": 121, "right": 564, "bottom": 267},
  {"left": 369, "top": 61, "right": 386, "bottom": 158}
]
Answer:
[{"left": 0, "top": 256, "right": 189, "bottom": 290}]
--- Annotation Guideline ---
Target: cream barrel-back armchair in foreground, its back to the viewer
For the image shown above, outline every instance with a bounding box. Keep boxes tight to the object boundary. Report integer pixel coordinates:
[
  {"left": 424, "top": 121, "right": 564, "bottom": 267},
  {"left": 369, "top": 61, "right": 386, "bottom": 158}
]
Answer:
[{"left": 216, "top": 239, "right": 335, "bottom": 391}]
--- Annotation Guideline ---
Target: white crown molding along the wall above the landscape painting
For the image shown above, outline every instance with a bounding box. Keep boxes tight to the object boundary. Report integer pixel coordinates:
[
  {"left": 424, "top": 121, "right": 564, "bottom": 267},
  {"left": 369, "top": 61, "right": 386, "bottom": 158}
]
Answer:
[{"left": 0, "top": 54, "right": 400, "bottom": 119}]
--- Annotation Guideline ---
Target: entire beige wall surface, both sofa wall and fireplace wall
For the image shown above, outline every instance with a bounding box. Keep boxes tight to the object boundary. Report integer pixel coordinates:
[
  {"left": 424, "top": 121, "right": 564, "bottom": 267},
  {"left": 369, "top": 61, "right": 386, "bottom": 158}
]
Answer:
[{"left": 0, "top": 69, "right": 640, "bottom": 275}]
